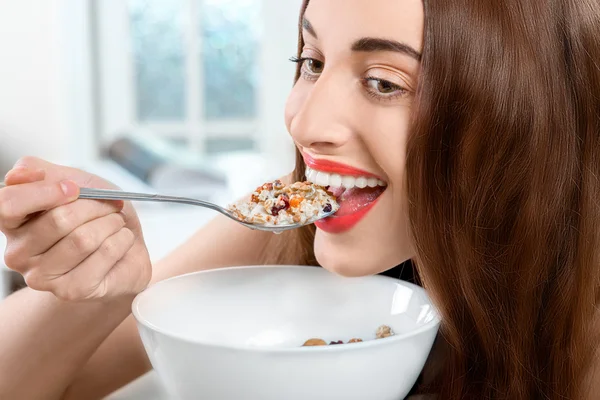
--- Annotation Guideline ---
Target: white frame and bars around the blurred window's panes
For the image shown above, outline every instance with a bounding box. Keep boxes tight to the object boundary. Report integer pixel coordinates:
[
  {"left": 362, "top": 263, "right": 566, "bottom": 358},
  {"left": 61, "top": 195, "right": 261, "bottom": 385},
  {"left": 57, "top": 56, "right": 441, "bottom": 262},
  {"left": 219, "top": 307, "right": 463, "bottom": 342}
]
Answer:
[{"left": 90, "top": 0, "right": 302, "bottom": 173}]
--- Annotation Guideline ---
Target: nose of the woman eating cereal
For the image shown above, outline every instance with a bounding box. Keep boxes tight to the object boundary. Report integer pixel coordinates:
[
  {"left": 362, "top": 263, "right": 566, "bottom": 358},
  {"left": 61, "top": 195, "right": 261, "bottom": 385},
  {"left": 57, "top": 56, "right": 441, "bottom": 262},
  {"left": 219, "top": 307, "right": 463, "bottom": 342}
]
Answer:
[{"left": 289, "top": 74, "right": 352, "bottom": 154}]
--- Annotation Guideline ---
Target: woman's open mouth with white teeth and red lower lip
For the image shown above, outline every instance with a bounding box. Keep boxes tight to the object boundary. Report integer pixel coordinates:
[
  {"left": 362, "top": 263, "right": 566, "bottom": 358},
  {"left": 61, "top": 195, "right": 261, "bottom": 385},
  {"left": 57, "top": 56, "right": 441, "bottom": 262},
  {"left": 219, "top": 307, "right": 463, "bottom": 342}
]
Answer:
[{"left": 306, "top": 167, "right": 387, "bottom": 233}]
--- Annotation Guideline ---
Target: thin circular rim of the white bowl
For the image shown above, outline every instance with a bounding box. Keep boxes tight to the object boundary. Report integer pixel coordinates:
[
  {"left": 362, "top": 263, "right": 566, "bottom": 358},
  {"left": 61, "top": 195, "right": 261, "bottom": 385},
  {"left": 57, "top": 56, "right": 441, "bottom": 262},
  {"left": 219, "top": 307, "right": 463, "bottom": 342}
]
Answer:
[{"left": 131, "top": 264, "right": 441, "bottom": 353}]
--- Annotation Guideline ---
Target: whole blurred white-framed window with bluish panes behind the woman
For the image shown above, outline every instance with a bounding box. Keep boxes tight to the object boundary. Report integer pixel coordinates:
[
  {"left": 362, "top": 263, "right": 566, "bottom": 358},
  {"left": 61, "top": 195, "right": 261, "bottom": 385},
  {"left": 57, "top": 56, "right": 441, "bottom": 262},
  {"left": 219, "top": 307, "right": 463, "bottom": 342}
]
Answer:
[{"left": 94, "top": 0, "right": 300, "bottom": 161}]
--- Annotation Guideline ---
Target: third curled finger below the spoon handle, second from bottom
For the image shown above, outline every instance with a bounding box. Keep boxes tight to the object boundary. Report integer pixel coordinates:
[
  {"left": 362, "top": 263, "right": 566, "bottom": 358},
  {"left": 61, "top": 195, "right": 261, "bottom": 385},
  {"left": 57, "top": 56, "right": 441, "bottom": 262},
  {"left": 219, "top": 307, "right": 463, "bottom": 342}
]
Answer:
[{"left": 25, "top": 228, "right": 135, "bottom": 301}]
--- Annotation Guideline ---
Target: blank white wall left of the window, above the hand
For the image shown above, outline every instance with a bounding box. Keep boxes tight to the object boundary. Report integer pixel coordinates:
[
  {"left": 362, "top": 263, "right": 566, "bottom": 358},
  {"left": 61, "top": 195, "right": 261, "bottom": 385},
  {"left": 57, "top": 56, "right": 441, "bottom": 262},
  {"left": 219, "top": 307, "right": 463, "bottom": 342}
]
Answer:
[{"left": 0, "top": 0, "right": 93, "bottom": 171}]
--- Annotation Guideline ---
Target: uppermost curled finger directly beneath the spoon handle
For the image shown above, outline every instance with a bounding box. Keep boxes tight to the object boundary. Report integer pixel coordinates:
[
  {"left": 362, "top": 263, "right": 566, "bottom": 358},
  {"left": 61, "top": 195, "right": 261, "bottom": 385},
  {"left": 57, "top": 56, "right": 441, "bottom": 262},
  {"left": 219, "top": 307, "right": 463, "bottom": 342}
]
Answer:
[{"left": 12, "top": 200, "right": 125, "bottom": 256}]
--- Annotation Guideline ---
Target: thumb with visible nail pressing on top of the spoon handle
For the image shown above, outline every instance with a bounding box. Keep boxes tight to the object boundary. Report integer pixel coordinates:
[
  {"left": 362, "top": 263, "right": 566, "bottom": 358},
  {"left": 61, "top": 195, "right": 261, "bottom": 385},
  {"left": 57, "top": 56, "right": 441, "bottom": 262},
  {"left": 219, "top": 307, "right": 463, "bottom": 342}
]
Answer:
[{"left": 0, "top": 180, "right": 79, "bottom": 230}]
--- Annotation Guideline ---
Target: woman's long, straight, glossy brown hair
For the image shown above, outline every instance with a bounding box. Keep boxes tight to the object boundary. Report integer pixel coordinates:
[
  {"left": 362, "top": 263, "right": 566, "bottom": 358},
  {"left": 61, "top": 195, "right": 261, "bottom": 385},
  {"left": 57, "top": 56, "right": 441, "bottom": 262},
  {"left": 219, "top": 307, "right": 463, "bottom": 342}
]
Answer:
[{"left": 264, "top": 0, "right": 600, "bottom": 400}]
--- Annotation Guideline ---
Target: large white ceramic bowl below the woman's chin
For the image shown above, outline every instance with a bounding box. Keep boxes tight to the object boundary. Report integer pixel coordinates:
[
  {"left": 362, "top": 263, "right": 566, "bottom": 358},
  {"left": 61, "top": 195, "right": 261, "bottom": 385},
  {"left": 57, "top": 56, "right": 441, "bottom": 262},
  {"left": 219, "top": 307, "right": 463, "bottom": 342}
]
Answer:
[{"left": 133, "top": 266, "right": 439, "bottom": 400}]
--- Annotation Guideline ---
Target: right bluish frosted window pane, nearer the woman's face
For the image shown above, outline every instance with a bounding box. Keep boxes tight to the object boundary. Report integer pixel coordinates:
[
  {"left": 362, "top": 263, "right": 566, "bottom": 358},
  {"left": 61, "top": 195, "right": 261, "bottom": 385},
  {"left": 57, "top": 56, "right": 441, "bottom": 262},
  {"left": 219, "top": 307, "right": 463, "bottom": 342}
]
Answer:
[{"left": 198, "top": 0, "right": 260, "bottom": 120}]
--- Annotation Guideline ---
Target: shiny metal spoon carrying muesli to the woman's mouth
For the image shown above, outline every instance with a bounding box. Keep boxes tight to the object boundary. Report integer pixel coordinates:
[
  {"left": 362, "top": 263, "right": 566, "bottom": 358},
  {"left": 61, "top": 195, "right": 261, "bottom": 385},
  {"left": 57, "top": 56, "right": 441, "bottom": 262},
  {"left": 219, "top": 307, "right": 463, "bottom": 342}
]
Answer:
[{"left": 0, "top": 182, "right": 335, "bottom": 233}]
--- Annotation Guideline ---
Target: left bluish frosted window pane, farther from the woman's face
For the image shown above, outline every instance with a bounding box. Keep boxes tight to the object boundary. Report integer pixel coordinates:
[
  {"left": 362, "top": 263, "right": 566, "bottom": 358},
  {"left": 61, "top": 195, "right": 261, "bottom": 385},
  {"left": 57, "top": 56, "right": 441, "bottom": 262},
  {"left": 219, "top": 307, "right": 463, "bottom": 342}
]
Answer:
[{"left": 129, "top": 0, "right": 186, "bottom": 121}]
